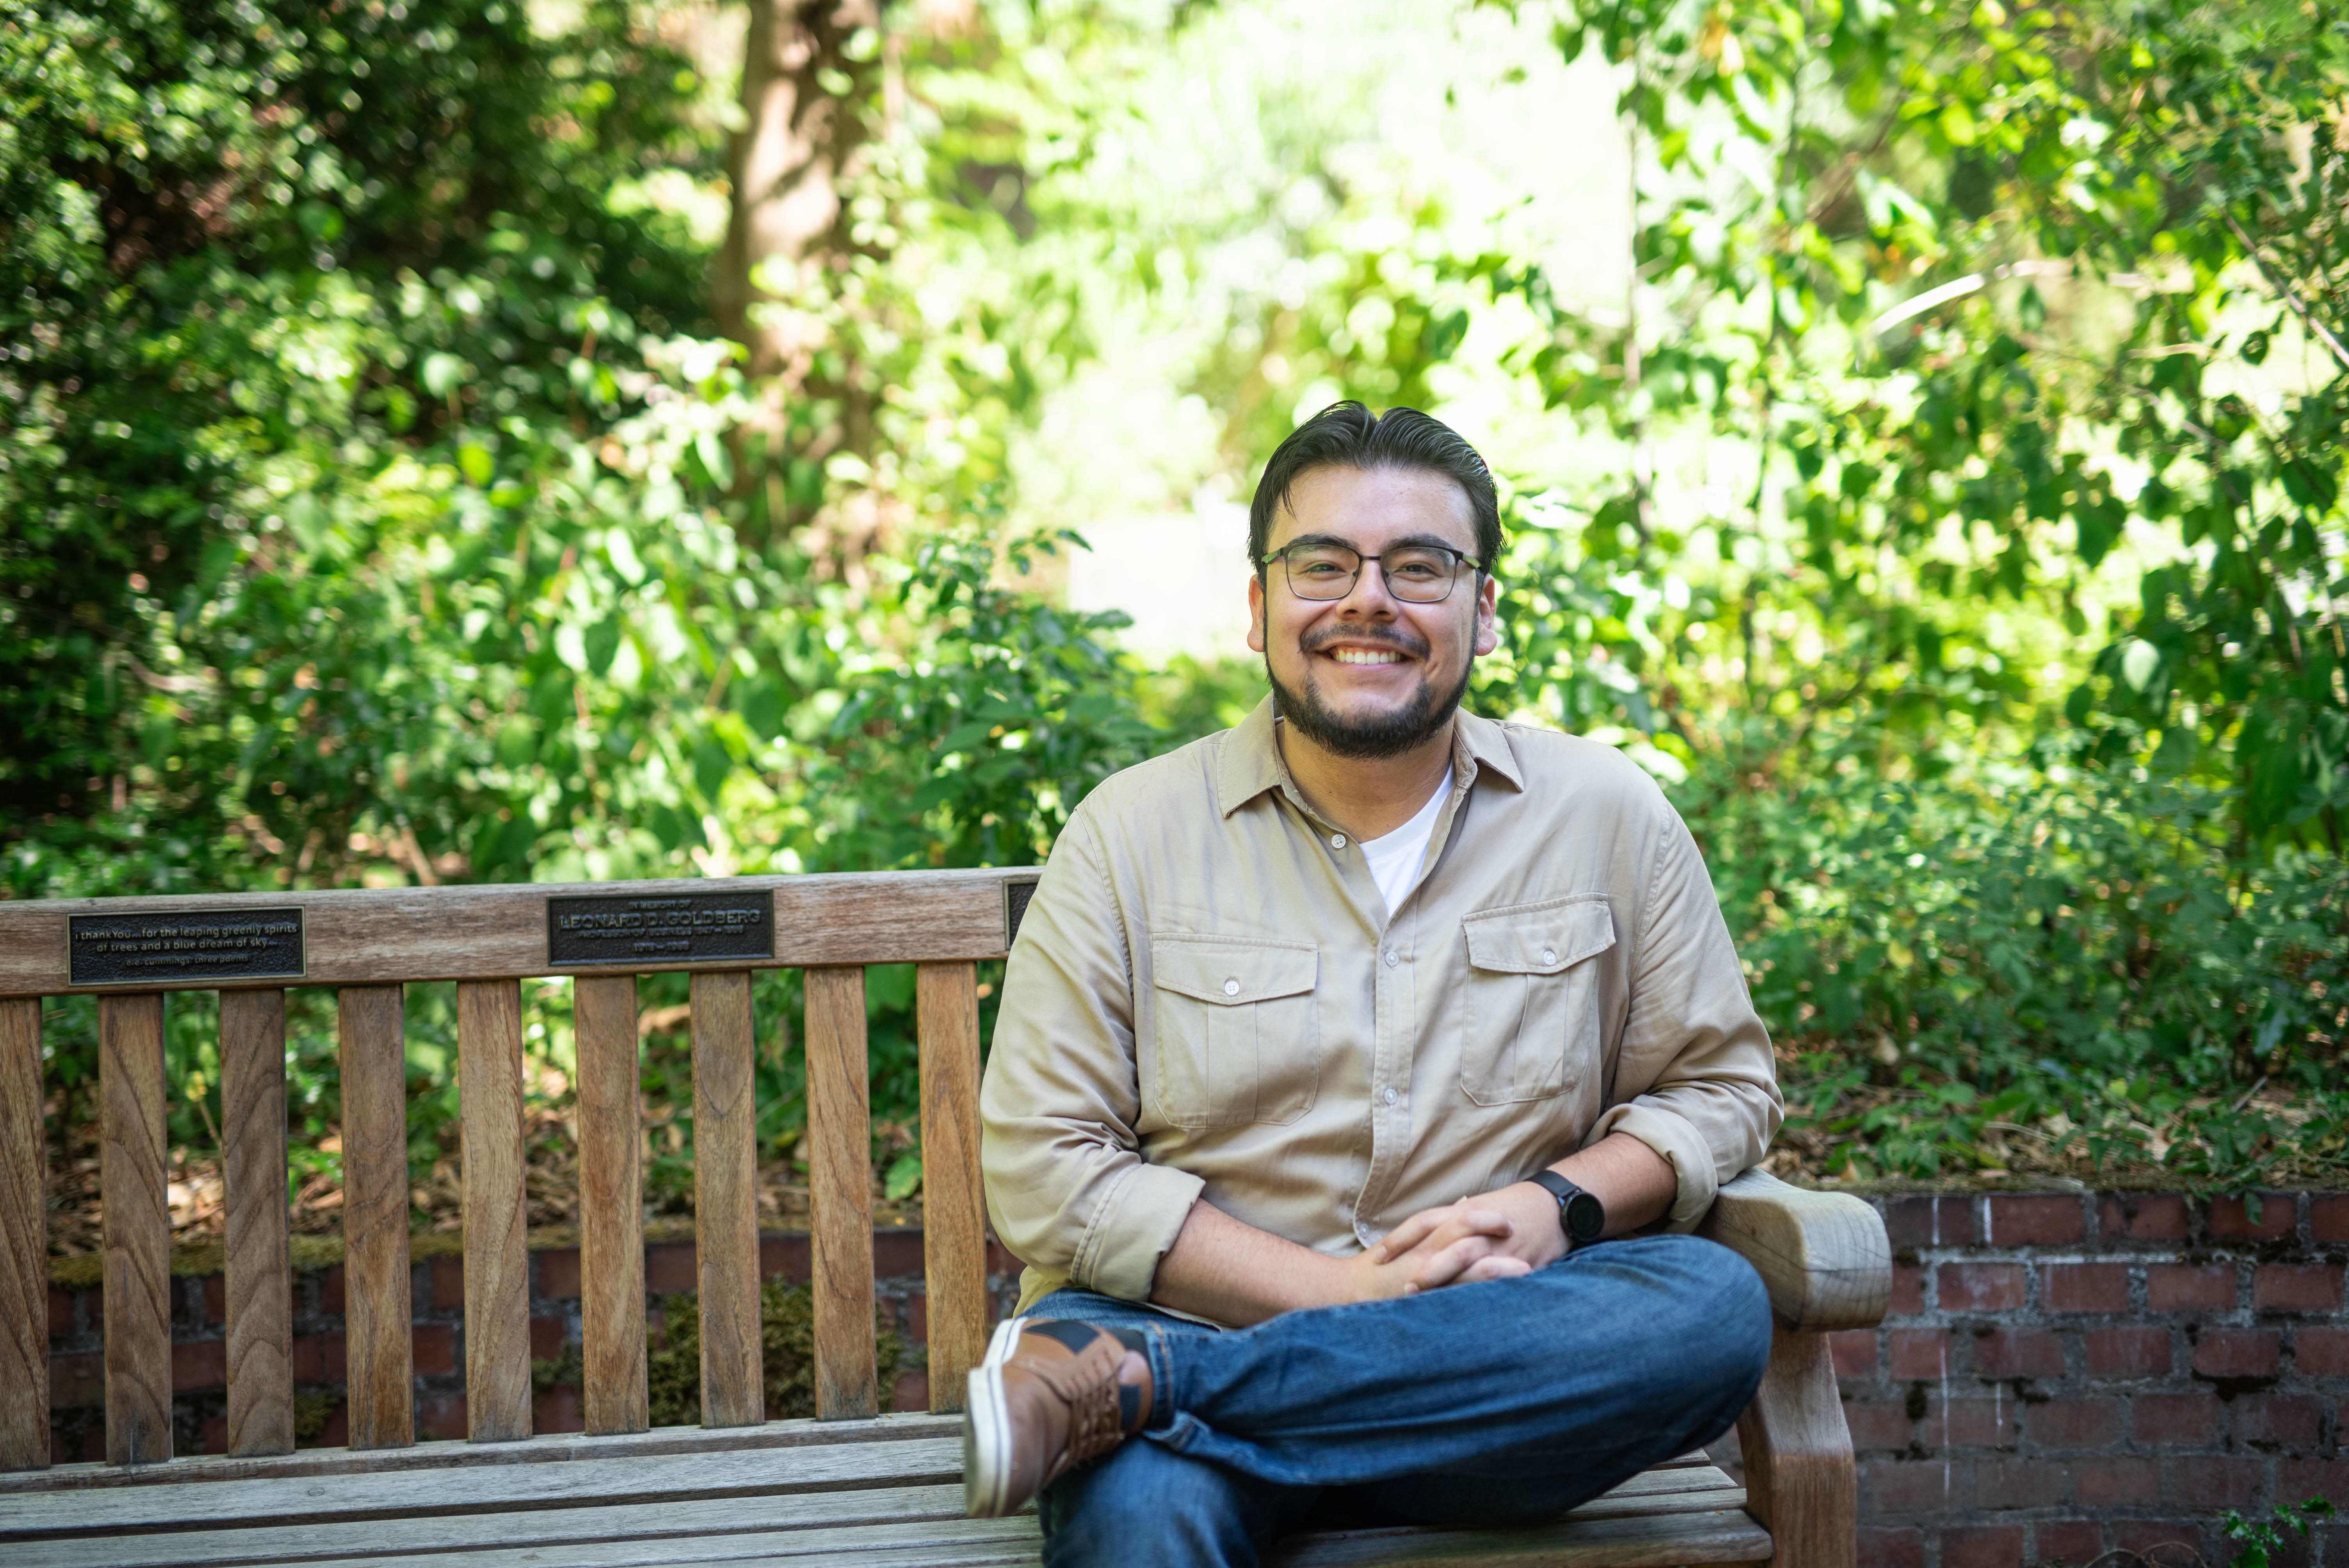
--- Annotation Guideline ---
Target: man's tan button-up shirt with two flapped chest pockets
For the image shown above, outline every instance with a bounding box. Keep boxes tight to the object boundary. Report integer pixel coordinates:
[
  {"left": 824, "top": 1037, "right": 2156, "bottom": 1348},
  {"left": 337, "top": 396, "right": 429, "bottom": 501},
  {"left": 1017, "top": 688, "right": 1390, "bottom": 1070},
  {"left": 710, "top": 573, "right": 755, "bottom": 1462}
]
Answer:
[{"left": 980, "top": 700, "right": 1785, "bottom": 1305}]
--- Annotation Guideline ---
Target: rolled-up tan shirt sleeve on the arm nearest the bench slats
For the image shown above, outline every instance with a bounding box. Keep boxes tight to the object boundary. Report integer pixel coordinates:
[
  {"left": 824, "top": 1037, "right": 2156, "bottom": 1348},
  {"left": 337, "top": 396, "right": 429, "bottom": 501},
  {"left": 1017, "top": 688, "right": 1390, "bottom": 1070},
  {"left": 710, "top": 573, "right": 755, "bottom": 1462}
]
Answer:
[{"left": 980, "top": 791, "right": 1203, "bottom": 1301}]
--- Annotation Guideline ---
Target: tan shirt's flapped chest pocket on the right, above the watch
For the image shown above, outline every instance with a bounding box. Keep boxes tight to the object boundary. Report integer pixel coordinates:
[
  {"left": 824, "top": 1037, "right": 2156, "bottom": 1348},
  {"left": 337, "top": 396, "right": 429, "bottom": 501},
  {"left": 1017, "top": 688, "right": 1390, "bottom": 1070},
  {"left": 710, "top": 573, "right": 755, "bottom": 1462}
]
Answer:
[{"left": 1461, "top": 892, "right": 1614, "bottom": 1106}]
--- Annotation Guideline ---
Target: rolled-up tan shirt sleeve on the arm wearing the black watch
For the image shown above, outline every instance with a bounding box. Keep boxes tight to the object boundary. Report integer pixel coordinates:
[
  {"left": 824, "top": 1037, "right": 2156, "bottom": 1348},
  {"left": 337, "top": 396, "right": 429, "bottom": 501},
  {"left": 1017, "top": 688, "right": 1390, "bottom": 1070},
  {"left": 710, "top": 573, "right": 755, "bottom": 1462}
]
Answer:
[{"left": 1583, "top": 796, "right": 1785, "bottom": 1230}]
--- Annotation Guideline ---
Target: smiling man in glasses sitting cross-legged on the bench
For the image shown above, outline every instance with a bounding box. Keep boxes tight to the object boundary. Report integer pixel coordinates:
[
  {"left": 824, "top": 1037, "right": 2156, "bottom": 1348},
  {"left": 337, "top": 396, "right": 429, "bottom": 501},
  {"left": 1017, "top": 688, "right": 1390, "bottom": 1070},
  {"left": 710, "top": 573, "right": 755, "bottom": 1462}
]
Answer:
[{"left": 963, "top": 404, "right": 1783, "bottom": 1568}]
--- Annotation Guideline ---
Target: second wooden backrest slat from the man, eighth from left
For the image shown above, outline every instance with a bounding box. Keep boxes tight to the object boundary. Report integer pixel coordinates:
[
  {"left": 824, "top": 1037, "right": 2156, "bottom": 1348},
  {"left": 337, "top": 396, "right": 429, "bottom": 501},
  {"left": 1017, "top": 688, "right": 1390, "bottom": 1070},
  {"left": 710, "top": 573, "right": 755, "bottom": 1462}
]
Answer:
[{"left": 806, "top": 969, "right": 879, "bottom": 1420}]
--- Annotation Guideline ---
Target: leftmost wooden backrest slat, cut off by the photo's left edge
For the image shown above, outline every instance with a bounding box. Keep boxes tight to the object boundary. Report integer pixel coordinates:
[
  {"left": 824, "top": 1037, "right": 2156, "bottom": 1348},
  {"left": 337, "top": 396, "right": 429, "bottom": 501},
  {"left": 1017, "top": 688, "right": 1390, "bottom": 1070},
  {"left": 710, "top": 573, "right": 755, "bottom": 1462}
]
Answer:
[{"left": 0, "top": 998, "right": 49, "bottom": 1469}]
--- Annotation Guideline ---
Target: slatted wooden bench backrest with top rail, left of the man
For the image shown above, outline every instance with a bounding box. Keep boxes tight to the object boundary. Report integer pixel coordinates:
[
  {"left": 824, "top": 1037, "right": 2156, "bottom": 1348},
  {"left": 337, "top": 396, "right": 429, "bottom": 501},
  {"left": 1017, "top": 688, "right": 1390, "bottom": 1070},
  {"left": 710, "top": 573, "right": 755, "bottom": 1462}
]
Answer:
[{"left": 0, "top": 871, "right": 1036, "bottom": 1469}]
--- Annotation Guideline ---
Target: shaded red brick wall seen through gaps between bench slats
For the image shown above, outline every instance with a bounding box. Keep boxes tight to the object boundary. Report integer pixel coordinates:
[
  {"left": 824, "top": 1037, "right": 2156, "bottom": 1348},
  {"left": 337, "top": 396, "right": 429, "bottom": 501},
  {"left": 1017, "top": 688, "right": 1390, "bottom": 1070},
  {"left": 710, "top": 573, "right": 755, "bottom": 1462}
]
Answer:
[{"left": 49, "top": 1230, "right": 1019, "bottom": 1465}]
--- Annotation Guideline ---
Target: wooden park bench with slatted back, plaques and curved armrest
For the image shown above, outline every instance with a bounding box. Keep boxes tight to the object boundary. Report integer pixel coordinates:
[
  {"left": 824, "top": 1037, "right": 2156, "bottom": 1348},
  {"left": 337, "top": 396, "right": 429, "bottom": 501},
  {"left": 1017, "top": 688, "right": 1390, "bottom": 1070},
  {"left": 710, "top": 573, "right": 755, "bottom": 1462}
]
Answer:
[{"left": 0, "top": 871, "right": 1891, "bottom": 1568}]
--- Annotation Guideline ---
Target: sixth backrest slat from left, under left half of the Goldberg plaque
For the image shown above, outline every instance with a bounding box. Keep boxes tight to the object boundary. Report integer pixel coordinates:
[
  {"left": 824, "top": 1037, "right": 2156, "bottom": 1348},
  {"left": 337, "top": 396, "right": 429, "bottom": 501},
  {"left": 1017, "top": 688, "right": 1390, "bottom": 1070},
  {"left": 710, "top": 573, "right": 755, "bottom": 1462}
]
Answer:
[{"left": 571, "top": 974, "right": 651, "bottom": 1432}]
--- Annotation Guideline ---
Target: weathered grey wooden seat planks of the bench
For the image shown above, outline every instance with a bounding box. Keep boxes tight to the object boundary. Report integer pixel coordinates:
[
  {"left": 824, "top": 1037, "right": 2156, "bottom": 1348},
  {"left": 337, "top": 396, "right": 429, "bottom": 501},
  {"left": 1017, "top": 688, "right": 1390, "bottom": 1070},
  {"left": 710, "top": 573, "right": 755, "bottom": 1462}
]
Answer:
[{"left": 0, "top": 1415, "right": 1769, "bottom": 1568}]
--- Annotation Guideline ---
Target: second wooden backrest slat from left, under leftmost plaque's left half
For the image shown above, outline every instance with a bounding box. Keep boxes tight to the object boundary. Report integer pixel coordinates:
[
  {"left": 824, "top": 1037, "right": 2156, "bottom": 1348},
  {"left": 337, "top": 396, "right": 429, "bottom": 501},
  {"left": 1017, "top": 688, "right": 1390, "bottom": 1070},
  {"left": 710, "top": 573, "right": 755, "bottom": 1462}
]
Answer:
[{"left": 99, "top": 991, "right": 171, "bottom": 1465}]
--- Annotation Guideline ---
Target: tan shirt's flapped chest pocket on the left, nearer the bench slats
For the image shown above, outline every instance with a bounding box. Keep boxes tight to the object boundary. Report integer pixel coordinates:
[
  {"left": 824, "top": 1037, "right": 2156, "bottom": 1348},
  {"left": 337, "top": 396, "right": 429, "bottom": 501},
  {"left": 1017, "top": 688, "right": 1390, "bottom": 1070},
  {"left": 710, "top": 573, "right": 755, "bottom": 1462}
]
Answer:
[{"left": 1151, "top": 932, "right": 1320, "bottom": 1127}]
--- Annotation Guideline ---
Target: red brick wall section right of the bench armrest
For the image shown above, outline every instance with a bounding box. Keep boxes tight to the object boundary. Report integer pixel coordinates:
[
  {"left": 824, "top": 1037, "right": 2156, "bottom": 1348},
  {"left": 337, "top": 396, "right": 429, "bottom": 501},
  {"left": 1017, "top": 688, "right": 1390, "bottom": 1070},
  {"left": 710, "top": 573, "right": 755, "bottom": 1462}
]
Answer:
[{"left": 1719, "top": 1192, "right": 2349, "bottom": 1568}]
